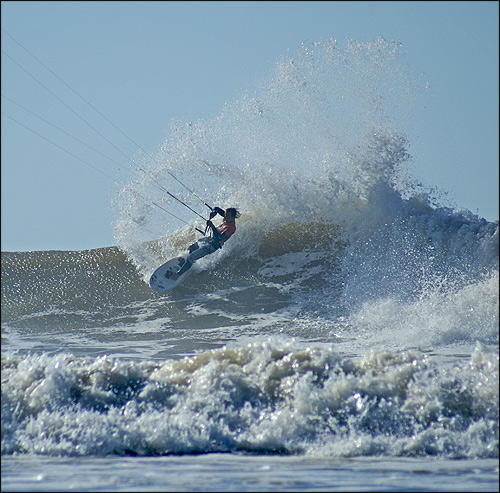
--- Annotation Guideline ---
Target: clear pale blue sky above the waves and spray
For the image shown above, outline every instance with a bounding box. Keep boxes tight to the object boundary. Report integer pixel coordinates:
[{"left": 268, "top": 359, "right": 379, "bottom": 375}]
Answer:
[{"left": 1, "top": 1, "right": 499, "bottom": 251}]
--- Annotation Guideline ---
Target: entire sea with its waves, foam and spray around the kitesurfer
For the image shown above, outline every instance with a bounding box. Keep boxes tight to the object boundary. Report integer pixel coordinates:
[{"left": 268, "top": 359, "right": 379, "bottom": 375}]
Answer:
[{"left": 1, "top": 39, "right": 499, "bottom": 491}]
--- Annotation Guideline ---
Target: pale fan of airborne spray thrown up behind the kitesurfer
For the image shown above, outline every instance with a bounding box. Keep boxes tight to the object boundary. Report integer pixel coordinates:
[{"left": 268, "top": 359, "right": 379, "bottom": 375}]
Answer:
[{"left": 115, "top": 38, "right": 421, "bottom": 279}]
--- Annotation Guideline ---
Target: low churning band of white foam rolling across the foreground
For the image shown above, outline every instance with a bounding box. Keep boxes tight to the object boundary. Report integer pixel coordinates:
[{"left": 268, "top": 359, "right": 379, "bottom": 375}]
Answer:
[{"left": 2, "top": 337, "right": 498, "bottom": 458}]
